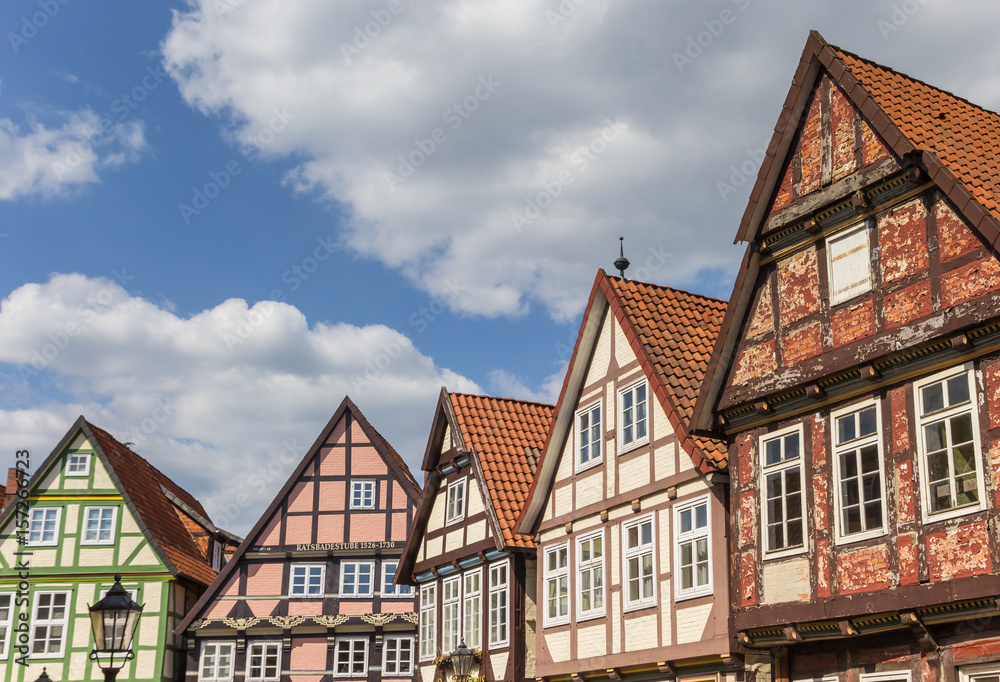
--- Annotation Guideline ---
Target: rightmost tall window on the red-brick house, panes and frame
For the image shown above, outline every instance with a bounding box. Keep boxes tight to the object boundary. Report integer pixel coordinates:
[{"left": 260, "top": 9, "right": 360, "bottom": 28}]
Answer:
[{"left": 914, "top": 367, "right": 985, "bottom": 518}]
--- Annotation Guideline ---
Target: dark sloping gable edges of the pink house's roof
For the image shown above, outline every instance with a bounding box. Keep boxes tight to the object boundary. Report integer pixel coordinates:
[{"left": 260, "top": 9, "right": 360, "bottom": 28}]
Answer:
[{"left": 174, "top": 396, "right": 420, "bottom": 635}]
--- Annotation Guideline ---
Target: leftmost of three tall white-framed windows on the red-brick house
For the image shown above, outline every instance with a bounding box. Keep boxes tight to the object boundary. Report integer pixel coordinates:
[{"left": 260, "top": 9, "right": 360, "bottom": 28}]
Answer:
[{"left": 760, "top": 426, "right": 805, "bottom": 554}]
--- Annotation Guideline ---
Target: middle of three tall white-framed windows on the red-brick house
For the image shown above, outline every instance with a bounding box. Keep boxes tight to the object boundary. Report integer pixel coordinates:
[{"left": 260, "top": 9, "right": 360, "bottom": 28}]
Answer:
[{"left": 832, "top": 401, "right": 885, "bottom": 541}]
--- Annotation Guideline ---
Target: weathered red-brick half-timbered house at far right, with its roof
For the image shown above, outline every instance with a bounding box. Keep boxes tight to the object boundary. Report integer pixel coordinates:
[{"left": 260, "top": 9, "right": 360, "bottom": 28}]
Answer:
[{"left": 696, "top": 33, "right": 1000, "bottom": 682}]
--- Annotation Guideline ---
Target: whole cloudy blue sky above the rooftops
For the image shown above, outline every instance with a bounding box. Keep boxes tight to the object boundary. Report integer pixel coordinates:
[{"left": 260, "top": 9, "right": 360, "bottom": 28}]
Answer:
[{"left": 0, "top": 0, "right": 1000, "bottom": 530}]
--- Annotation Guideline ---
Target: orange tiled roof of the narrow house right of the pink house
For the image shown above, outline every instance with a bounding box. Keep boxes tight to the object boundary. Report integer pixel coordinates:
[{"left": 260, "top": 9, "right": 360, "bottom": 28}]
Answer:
[{"left": 450, "top": 393, "right": 553, "bottom": 547}]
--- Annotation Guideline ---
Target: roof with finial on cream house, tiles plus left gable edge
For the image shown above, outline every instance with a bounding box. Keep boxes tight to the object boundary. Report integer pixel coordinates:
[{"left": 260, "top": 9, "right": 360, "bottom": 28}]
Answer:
[{"left": 518, "top": 269, "right": 728, "bottom": 534}]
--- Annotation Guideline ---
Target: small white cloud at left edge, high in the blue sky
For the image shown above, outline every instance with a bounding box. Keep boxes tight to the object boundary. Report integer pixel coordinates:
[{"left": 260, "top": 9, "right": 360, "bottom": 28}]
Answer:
[{"left": 0, "top": 109, "right": 148, "bottom": 200}]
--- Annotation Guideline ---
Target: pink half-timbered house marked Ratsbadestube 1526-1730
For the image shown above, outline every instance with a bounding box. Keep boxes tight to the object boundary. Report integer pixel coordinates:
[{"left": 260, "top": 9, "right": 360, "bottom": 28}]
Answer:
[{"left": 177, "top": 398, "right": 420, "bottom": 682}]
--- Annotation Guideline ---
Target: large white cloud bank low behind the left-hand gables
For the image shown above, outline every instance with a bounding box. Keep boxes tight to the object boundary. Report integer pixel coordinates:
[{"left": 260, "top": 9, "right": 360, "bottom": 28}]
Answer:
[{"left": 0, "top": 274, "right": 479, "bottom": 531}]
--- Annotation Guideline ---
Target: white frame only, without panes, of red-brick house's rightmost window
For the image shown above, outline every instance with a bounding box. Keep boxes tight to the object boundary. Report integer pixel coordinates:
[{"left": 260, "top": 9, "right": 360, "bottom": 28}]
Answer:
[{"left": 913, "top": 362, "right": 986, "bottom": 523}]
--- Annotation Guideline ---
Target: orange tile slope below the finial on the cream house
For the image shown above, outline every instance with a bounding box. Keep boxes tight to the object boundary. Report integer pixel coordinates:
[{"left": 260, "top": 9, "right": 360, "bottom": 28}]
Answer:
[{"left": 608, "top": 276, "right": 728, "bottom": 467}]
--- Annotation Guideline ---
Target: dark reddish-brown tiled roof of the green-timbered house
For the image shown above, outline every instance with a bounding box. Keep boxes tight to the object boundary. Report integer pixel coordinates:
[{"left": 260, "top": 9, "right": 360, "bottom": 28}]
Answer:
[{"left": 88, "top": 422, "right": 216, "bottom": 585}]
